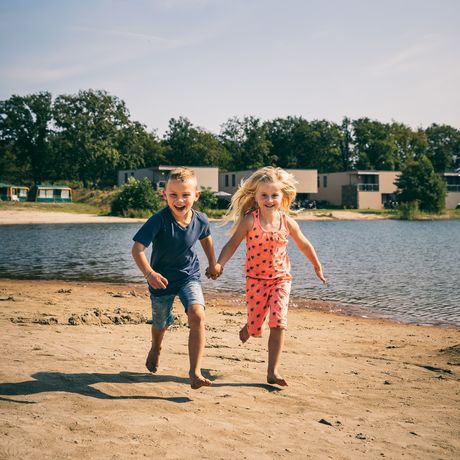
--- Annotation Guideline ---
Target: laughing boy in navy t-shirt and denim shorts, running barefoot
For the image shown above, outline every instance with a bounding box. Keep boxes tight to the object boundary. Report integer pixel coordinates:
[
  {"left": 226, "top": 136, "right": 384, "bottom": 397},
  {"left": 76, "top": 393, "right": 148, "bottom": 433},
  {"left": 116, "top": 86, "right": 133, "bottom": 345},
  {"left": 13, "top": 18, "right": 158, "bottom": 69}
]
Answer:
[{"left": 132, "top": 168, "right": 217, "bottom": 389}]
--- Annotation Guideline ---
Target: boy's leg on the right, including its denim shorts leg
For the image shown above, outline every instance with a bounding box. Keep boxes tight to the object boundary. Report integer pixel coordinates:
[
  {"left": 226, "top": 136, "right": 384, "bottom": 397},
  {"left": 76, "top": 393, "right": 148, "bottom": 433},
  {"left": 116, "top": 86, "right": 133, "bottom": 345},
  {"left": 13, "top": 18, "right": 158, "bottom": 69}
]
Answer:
[{"left": 179, "top": 280, "right": 211, "bottom": 390}]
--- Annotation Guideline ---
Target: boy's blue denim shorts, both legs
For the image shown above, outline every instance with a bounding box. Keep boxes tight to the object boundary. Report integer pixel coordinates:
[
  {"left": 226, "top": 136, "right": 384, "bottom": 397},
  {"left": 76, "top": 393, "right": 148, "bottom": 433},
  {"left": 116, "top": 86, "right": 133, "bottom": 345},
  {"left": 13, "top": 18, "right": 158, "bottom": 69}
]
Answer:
[{"left": 150, "top": 280, "right": 204, "bottom": 329}]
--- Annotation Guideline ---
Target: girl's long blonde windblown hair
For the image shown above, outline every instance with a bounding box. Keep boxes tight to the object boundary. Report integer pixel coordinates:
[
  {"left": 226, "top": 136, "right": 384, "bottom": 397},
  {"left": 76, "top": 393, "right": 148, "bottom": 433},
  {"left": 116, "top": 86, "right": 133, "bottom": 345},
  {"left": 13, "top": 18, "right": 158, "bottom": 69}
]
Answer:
[{"left": 224, "top": 166, "right": 297, "bottom": 234}]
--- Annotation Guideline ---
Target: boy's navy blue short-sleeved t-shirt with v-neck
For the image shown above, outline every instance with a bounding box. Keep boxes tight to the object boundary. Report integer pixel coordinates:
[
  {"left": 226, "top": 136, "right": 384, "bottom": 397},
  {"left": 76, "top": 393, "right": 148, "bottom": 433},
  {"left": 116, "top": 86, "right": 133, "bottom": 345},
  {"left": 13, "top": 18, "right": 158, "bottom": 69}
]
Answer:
[{"left": 133, "top": 206, "right": 211, "bottom": 296}]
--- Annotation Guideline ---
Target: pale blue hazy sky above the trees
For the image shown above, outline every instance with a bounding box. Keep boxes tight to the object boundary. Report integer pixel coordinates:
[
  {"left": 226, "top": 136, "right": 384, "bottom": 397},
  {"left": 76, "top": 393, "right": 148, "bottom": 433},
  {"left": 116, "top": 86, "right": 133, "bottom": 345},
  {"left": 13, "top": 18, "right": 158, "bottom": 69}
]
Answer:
[{"left": 0, "top": 0, "right": 460, "bottom": 136}]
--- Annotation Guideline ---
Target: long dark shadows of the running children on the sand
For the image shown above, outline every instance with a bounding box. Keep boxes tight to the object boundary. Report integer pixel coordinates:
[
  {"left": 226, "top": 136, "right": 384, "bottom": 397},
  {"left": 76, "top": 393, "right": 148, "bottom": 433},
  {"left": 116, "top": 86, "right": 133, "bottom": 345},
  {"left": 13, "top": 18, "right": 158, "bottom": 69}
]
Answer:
[{"left": 0, "top": 369, "right": 280, "bottom": 404}]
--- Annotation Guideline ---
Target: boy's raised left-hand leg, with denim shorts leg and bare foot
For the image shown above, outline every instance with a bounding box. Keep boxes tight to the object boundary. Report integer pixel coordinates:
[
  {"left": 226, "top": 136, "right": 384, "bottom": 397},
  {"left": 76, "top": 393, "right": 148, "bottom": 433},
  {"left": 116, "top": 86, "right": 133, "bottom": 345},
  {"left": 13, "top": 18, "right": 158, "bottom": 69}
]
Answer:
[{"left": 145, "top": 295, "right": 175, "bottom": 372}]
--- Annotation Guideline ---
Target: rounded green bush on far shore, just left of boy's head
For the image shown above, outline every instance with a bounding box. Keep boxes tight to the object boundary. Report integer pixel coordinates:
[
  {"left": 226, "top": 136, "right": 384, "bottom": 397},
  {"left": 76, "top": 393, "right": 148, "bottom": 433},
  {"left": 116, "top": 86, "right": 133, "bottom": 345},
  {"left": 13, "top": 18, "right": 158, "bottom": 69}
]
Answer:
[{"left": 111, "top": 177, "right": 164, "bottom": 217}]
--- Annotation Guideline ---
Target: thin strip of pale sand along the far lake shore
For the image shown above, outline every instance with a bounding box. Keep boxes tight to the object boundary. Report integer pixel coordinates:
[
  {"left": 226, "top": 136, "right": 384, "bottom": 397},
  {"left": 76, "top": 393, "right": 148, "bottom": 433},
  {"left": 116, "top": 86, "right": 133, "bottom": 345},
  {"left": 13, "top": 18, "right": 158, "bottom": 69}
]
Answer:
[{"left": 0, "top": 208, "right": 388, "bottom": 225}]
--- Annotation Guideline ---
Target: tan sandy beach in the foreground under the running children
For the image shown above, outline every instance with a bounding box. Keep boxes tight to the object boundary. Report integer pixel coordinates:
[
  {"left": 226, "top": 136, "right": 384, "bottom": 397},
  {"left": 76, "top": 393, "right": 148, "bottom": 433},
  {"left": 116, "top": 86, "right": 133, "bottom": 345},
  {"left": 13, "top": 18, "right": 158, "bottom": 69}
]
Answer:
[{"left": 0, "top": 279, "right": 460, "bottom": 459}]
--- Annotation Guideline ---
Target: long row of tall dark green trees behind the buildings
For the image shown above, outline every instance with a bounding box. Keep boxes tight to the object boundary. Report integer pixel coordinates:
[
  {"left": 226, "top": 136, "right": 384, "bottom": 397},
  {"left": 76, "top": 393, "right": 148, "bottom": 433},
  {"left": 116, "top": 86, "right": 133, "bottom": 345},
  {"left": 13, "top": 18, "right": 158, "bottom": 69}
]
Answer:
[{"left": 0, "top": 89, "right": 460, "bottom": 187}]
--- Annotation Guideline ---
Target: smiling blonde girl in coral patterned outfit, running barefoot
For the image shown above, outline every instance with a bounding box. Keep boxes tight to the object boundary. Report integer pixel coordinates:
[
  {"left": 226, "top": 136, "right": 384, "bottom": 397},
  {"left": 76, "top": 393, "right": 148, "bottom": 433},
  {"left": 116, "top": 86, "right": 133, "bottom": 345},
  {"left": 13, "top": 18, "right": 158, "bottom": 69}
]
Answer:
[{"left": 215, "top": 167, "right": 326, "bottom": 386}]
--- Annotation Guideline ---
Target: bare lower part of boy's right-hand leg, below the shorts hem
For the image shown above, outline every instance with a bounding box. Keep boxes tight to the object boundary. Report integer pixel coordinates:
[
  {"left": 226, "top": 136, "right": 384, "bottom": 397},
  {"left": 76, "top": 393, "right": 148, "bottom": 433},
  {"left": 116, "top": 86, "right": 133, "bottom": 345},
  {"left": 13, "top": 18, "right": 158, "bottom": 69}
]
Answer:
[{"left": 187, "top": 304, "right": 211, "bottom": 390}]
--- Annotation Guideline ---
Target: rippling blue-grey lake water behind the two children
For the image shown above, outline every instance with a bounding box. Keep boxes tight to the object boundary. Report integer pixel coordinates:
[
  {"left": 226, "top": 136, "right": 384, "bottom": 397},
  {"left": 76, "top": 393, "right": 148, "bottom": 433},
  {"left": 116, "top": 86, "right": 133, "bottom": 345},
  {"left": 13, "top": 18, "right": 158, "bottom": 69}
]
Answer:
[{"left": 0, "top": 220, "right": 460, "bottom": 326}]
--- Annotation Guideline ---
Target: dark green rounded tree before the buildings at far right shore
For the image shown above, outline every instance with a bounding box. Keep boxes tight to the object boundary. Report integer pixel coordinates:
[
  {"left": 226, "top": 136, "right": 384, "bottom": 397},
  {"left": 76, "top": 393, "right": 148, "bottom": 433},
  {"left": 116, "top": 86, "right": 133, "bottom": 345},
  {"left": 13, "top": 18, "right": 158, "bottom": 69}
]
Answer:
[{"left": 396, "top": 155, "right": 446, "bottom": 213}]
